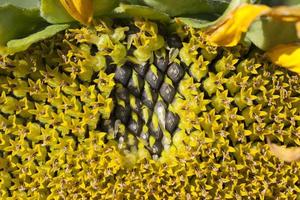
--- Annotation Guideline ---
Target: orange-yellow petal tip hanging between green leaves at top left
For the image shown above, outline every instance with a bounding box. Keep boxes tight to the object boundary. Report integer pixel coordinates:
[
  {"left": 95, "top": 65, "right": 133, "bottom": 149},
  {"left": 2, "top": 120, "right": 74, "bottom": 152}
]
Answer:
[{"left": 60, "top": 0, "right": 93, "bottom": 25}]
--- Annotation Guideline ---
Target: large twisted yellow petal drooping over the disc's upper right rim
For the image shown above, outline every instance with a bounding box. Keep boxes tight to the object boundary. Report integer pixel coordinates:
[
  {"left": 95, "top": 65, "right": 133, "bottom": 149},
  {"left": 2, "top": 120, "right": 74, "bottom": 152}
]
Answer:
[{"left": 207, "top": 4, "right": 270, "bottom": 46}]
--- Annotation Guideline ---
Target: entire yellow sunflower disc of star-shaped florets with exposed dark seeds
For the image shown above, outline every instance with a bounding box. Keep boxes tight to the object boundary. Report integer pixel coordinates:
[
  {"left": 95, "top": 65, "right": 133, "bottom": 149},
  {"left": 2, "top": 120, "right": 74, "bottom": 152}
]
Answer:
[{"left": 0, "top": 20, "right": 300, "bottom": 199}]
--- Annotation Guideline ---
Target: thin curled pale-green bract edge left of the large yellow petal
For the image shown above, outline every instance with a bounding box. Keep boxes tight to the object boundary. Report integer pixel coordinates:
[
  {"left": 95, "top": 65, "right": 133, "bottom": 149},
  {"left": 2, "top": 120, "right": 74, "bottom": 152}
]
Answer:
[{"left": 177, "top": 0, "right": 249, "bottom": 28}]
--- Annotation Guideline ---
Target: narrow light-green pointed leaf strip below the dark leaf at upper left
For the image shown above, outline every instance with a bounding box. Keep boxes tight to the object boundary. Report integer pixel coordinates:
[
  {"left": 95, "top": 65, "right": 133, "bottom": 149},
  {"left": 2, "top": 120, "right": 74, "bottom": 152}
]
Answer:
[{"left": 4, "top": 24, "right": 69, "bottom": 54}]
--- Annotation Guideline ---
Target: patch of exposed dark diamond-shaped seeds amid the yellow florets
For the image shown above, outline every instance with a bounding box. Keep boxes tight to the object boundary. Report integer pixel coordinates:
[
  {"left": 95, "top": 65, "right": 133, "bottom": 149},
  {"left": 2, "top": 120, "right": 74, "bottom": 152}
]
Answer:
[{"left": 102, "top": 55, "right": 185, "bottom": 154}]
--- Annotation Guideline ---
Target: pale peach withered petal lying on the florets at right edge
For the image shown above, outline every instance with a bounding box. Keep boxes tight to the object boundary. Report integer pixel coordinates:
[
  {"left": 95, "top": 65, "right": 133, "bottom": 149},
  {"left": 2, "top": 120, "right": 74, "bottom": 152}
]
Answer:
[{"left": 268, "top": 139, "right": 300, "bottom": 162}]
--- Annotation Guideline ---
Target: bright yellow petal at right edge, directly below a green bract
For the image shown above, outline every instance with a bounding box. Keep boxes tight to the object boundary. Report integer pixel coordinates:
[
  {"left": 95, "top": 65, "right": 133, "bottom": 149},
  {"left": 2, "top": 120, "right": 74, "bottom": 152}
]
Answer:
[{"left": 266, "top": 43, "right": 300, "bottom": 74}]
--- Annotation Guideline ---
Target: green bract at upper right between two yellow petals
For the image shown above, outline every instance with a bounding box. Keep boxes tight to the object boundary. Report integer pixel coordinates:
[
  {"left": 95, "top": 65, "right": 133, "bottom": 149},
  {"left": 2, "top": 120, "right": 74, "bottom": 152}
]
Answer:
[{"left": 246, "top": 17, "right": 300, "bottom": 50}]
